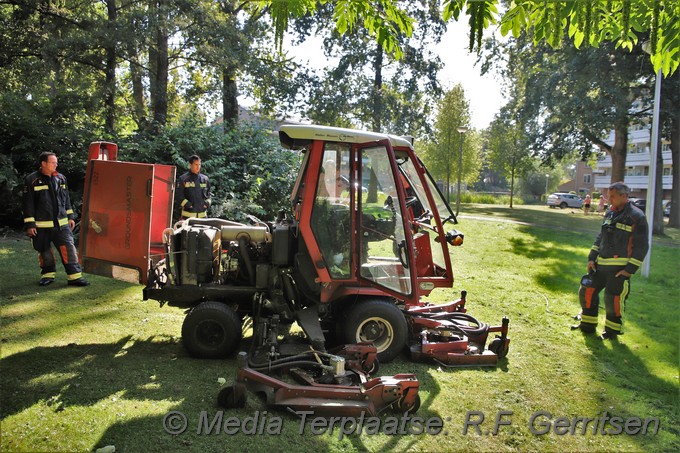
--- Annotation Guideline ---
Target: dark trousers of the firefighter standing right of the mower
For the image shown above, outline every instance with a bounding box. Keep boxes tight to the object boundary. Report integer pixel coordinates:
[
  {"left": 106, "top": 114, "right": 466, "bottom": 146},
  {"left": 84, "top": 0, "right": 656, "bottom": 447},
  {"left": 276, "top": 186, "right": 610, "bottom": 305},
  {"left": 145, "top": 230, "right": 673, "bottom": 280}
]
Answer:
[{"left": 579, "top": 266, "right": 630, "bottom": 334}]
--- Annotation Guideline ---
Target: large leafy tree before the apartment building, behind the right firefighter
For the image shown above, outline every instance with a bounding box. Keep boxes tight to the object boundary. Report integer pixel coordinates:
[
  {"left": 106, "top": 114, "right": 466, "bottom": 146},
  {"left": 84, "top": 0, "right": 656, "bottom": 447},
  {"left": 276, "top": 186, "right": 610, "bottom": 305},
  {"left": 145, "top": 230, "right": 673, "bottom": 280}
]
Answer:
[{"left": 492, "top": 31, "right": 652, "bottom": 185}]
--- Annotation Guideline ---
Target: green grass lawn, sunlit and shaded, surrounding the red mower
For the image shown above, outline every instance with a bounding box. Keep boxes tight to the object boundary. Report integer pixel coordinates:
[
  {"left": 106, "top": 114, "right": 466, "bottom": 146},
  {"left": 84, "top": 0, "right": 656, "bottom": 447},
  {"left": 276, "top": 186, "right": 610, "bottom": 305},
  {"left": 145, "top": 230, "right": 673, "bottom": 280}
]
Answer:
[{"left": 0, "top": 205, "right": 680, "bottom": 452}]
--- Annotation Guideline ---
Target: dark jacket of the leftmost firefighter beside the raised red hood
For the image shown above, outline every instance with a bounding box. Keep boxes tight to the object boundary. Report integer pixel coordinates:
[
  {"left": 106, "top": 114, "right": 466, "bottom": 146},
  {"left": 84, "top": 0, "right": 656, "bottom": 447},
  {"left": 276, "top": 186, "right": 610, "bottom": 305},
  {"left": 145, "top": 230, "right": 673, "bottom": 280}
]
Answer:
[{"left": 23, "top": 171, "right": 76, "bottom": 229}]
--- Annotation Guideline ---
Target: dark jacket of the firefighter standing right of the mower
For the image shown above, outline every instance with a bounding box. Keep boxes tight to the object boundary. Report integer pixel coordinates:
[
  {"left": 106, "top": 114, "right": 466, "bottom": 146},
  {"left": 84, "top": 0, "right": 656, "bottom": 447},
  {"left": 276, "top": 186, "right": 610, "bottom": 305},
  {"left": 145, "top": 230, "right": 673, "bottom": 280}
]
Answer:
[{"left": 588, "top": 202, "right": 649, "bottom": 274}]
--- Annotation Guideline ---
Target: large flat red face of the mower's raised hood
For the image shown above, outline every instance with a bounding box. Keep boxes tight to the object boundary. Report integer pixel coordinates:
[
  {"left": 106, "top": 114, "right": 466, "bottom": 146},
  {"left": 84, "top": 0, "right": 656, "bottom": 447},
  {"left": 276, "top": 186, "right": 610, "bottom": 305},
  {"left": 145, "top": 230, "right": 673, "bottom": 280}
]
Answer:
[{"left": 80, "top": 160, "right": 154, "bottom": 283}]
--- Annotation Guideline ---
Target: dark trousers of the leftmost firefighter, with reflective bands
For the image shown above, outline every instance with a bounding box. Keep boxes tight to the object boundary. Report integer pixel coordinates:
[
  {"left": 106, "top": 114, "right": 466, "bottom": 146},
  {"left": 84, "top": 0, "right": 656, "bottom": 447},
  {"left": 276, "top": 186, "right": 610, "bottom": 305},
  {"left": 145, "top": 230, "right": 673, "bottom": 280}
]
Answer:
[{"left": 31, "top": 225, "right": 82, "bottom": 280}]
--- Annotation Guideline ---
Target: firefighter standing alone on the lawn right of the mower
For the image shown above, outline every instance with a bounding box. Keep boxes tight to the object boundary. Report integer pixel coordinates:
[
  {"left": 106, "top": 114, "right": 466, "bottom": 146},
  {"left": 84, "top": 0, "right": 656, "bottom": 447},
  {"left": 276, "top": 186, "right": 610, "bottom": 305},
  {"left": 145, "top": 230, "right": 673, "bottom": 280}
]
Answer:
[{"left": 573, "top": 182, "right": 649, "bottom": 339}]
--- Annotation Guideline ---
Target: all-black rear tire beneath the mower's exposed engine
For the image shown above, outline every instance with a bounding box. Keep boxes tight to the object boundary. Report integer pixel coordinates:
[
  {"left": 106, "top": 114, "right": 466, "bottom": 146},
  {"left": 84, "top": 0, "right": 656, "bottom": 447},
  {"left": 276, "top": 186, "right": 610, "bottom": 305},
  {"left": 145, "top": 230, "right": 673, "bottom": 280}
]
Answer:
[{"left": 182, "top": 301, "right": 242, "bottom": 359}]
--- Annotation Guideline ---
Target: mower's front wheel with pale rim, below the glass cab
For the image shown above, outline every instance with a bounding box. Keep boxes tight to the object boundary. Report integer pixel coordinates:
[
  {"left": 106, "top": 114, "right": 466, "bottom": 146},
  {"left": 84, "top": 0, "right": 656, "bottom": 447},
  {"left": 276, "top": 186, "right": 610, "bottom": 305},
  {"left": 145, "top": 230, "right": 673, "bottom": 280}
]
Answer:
[{"left": 342, "top": 300, "right": 408, "bottom": 363}]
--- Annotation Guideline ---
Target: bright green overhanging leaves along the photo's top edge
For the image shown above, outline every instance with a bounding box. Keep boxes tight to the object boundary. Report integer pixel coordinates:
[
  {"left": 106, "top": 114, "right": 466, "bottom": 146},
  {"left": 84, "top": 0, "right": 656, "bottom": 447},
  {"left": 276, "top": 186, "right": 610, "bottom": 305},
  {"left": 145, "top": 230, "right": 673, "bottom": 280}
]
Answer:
[{"left": 261, "top": 0, "right": 680, "bottom": 76}]
